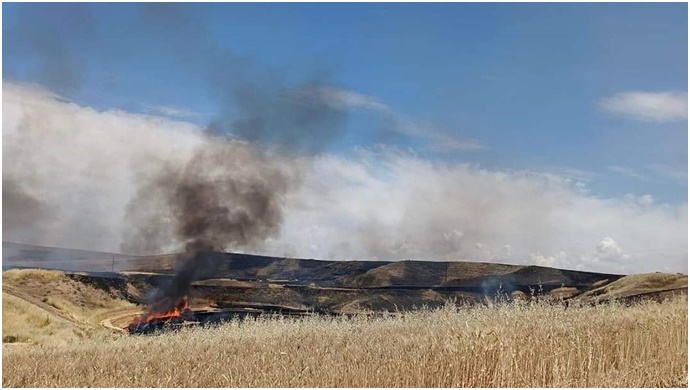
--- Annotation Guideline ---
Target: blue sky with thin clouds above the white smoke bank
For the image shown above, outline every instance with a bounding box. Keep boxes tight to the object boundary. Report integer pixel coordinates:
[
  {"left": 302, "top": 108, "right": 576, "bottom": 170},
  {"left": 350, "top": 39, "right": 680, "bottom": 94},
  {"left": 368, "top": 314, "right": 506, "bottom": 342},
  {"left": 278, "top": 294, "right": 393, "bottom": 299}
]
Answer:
[{"left": 2, "top": 3, "right": 688, "bottom": 204}]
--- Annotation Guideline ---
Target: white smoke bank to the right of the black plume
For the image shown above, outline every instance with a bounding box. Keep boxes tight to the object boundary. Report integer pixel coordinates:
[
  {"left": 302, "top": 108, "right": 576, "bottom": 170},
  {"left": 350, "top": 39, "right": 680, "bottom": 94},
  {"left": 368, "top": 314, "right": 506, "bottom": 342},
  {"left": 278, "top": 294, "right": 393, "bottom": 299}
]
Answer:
[{"left": 275, "top": 151, "right": 687, "bottom": 272}]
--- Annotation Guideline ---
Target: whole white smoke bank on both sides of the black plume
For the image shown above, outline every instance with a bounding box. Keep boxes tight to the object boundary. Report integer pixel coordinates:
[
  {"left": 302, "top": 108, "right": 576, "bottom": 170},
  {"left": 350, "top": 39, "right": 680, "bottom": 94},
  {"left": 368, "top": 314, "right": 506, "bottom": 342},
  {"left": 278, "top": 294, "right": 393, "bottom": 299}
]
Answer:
[{"left": 3, "top": 81, "right": 688, "bottom": 273}]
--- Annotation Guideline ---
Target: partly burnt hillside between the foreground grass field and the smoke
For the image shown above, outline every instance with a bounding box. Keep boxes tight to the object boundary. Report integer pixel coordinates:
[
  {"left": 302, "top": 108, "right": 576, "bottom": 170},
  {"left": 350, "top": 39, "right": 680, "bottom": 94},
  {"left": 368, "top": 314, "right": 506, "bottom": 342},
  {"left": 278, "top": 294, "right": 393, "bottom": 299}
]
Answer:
[{"left": 2, "top": 243, "right": 687, "bottom": 343}]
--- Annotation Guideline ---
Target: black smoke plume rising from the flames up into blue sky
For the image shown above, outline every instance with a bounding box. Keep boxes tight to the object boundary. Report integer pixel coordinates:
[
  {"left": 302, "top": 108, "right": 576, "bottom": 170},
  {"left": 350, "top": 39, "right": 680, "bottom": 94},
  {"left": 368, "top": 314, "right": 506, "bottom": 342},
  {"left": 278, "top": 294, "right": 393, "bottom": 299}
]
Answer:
[{"left": 122, "top": 4, "right": 347, "bottom": 311}]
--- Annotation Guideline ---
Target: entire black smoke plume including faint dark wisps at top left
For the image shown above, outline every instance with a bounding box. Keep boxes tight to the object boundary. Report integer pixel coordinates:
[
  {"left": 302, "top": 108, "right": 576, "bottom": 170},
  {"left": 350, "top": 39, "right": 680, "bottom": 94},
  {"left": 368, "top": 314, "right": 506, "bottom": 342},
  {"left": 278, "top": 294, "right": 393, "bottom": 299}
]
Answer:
[{"left": 8, "top": 4, "right": 347, "bottom": 314}]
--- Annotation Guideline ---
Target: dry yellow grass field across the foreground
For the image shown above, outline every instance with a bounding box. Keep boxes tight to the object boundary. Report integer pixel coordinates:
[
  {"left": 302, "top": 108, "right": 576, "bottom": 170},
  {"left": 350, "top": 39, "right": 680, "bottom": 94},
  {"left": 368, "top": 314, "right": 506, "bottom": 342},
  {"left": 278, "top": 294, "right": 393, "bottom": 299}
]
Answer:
[{"left": 2, "top": 297, "right": 688, "bottom": 387}]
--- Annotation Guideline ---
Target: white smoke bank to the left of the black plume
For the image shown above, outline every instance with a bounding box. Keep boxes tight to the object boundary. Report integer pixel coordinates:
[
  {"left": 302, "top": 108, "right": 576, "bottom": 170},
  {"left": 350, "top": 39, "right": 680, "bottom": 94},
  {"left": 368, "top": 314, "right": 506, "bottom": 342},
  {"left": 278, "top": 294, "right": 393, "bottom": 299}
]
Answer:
[{"left": 2, "top": 81, "right": 202, "bottom": 250}]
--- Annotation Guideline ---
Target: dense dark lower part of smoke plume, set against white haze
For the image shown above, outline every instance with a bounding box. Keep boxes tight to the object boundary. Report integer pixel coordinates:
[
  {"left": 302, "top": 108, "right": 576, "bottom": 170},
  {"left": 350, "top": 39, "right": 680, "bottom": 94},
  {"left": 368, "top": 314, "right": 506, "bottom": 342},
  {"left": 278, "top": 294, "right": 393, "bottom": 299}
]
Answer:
[{"left": 123, "top": 138, "right": 288, "bottom": 312}]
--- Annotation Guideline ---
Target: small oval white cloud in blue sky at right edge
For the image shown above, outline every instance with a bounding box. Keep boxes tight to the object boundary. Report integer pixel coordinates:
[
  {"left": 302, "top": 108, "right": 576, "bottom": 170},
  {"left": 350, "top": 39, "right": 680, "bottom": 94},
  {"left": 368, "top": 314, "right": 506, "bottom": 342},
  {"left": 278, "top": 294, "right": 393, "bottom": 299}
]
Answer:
[{"left": 599, "top": 91, "right": 688, "bottom": 122}]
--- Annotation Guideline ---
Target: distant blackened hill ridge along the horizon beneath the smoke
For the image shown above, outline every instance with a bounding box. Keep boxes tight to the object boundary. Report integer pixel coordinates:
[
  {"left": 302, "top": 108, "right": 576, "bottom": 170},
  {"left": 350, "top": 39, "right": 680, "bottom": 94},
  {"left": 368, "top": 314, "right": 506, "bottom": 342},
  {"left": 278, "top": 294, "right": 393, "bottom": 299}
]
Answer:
[{"left": 3, "top": 241, "right": 623, "bottom": 293}]
